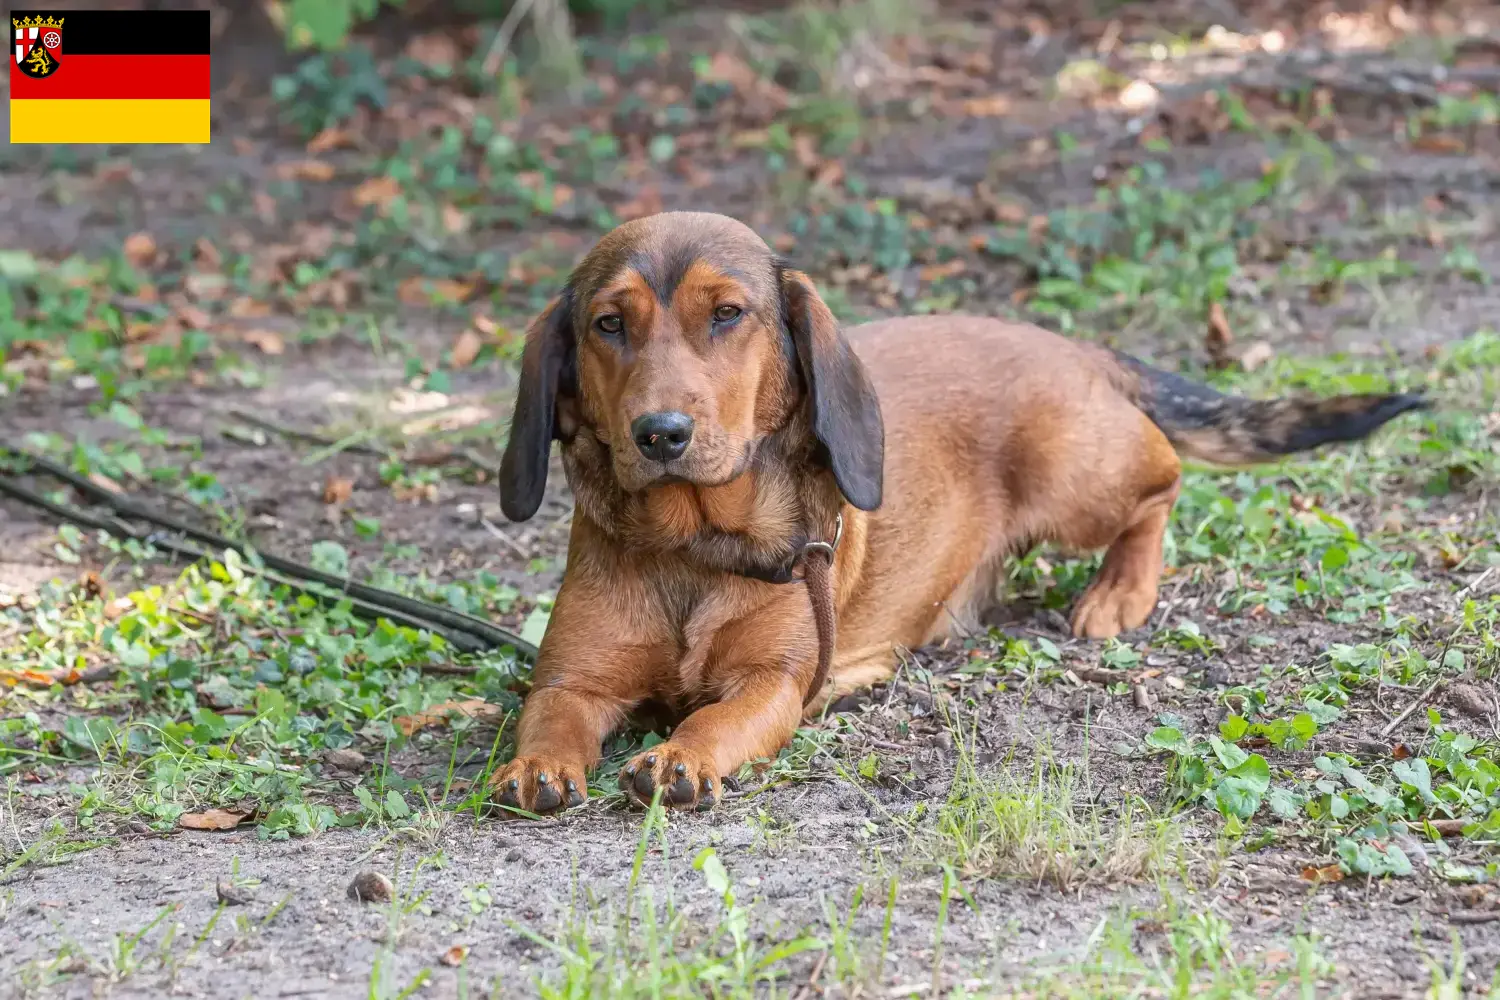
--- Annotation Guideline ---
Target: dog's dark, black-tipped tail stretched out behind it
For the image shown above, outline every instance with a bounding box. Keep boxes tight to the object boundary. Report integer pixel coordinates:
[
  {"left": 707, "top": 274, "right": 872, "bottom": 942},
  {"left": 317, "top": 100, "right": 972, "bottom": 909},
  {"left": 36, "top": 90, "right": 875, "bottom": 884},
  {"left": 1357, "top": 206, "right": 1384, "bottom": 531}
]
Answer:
[{"left": 1113, "top": 351, "right": 1428, "bottom": 465}]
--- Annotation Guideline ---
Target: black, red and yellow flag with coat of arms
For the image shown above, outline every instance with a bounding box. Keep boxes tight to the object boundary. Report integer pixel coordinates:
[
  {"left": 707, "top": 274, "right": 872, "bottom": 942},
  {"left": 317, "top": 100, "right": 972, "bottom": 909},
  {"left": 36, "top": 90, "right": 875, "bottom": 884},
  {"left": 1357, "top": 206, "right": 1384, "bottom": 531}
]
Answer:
[{"left": 11, "top": 10, "right": 209, "bottom": 142}]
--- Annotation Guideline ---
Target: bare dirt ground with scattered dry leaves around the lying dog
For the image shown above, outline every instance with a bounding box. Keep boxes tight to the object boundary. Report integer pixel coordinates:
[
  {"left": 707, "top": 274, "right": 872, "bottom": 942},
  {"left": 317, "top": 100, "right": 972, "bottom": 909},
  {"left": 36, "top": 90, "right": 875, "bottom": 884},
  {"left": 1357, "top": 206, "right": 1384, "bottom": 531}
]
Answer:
[{"left": 0, "top": 0, "right": 1500, "bottom": 997}]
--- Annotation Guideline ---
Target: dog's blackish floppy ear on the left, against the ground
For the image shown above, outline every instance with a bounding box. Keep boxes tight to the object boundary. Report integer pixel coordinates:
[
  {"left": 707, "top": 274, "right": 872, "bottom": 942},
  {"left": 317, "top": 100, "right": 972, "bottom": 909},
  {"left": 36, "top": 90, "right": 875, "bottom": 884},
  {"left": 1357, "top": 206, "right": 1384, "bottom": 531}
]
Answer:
[{"left": 500, "top": 292, "right": 573, "bottom": 520}]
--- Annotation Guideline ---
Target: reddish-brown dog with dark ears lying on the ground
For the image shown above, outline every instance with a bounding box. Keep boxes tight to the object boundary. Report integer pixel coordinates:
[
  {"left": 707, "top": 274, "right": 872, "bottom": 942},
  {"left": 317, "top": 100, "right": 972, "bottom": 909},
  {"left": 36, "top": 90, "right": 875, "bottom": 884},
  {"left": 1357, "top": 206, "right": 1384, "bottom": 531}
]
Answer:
[{"left": 492, "top": 213, "right": 1422, "bottom": 813}]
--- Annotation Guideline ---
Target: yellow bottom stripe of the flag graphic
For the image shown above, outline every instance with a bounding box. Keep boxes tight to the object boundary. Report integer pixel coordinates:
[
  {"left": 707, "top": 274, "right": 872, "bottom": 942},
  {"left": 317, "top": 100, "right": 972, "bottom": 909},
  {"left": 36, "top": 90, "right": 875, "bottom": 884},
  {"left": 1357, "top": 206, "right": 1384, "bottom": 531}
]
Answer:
[{"left": 11, "top": 100, "right": 209, "bottom": 142}]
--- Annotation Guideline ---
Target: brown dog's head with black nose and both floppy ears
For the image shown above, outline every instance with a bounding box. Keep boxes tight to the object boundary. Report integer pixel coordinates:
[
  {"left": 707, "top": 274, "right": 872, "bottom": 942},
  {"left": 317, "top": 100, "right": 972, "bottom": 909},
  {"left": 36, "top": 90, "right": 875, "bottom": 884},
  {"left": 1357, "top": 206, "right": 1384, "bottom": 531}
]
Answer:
[{"left": 500, "top": 213, "right": 885, "bottom": 520}]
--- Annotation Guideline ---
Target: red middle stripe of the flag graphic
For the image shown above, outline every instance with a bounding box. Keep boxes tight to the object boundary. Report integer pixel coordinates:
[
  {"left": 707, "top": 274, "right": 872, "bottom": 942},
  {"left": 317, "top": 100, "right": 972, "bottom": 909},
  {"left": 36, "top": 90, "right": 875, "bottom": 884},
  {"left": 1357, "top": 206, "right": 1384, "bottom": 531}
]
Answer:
[{"left": 9, "top": 55, "right": 209, "bottom": 100}]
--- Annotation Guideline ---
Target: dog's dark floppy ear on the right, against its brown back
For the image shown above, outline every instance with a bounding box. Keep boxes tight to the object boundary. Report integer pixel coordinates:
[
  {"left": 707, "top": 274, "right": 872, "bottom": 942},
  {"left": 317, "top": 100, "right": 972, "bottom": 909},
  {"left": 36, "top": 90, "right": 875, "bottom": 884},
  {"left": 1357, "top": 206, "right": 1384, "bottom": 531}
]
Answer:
[{"left": 782, "top": 270, "right": 885, "bottom": 510}]
